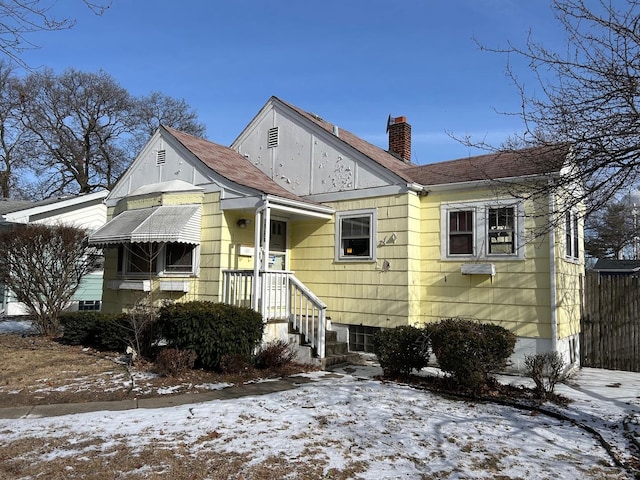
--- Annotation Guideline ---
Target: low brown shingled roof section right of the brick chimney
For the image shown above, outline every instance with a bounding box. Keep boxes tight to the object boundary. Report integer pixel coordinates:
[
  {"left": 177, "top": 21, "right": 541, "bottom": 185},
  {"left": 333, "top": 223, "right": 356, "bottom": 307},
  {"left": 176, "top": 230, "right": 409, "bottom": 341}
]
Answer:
[{"left": 406, "top": 146, "right": 569, "bottom": 185}]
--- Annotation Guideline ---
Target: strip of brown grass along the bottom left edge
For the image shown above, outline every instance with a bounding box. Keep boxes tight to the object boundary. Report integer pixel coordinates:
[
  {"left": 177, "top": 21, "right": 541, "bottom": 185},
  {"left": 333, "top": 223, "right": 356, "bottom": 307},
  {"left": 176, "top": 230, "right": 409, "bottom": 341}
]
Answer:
[{"left": 0, "top": 437, "right": 367, "bottom": 480}]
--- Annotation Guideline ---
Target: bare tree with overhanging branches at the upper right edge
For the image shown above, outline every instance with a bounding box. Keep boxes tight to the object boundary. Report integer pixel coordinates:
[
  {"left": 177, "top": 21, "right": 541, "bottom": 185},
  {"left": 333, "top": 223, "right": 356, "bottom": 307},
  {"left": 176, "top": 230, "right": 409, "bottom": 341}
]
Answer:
[{"left": 463, "top": 0, "right": 640, "bottom": 218}]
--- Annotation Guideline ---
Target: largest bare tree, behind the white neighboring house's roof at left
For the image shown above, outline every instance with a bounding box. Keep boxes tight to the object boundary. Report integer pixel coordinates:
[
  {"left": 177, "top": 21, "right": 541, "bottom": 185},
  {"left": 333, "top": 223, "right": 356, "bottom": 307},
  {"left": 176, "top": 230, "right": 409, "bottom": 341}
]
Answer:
[{"left": 21, "top": 69, "right": 134, "bottom": 198}]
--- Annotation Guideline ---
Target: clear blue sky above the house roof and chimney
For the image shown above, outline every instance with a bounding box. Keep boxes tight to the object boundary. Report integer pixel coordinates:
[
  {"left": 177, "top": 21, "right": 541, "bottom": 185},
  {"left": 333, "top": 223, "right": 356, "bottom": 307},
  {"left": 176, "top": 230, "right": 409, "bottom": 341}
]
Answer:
[{"left": 16, "top": 0, "right": 563, "bottom": 164}]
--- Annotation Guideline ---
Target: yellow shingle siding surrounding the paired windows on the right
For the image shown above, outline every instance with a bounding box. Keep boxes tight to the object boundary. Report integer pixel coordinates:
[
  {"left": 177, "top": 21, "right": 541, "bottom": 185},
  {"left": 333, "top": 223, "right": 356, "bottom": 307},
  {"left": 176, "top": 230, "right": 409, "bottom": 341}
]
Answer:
[{"left": 421, "top": 189, "right": 551, "bottom": 338}]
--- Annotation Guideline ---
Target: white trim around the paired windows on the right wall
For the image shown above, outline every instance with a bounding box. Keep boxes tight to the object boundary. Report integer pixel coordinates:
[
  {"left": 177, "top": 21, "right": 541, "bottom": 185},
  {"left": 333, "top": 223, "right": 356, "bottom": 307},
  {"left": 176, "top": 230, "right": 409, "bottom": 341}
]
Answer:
[{"left": 440, "top": 199, "right": 525, "bottom": 261}]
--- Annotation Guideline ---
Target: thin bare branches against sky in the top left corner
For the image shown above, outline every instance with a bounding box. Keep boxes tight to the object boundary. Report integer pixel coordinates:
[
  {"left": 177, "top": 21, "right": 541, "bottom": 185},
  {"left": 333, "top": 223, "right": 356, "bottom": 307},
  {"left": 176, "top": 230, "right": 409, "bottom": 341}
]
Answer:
[{"left": 0, "top": 0, "right": 111, "bottom": 67}]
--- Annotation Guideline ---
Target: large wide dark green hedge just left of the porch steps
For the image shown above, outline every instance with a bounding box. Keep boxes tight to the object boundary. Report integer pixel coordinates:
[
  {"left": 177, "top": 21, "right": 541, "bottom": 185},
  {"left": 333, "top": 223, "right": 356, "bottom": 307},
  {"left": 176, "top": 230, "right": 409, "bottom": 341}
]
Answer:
[{"left": 157, "top": 301, "right": 264, "bottom": 370}]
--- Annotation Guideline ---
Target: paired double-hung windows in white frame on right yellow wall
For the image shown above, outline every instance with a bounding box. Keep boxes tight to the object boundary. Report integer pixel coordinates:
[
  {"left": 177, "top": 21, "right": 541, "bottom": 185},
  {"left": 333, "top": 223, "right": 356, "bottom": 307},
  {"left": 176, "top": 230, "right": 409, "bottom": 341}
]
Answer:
[{"left": 440, "top": 200, "right": 524, "bottom": 260}]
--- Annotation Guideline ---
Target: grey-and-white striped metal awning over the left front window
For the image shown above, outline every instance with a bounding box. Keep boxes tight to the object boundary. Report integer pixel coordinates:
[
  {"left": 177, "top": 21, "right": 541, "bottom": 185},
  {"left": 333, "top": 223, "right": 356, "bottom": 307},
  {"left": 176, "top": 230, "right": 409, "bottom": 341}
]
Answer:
[{"left": 89, "top": 205, "right": 201, "bottom": 246}]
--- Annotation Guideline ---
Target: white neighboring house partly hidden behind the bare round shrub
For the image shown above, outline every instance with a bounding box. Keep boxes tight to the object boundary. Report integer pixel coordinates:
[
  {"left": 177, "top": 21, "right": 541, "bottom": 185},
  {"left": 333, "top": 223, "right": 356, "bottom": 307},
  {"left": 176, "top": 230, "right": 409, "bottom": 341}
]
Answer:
[{"left": 0, "top": 190, "right": 109, "bottom": 315}]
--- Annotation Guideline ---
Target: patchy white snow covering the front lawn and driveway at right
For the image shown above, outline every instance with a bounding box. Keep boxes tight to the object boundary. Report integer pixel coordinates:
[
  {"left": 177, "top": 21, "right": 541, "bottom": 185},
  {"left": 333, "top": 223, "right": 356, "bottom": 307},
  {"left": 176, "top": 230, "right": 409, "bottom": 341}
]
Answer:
[{"left": 0, "top": 318, "right": 640, "bottom": 480}]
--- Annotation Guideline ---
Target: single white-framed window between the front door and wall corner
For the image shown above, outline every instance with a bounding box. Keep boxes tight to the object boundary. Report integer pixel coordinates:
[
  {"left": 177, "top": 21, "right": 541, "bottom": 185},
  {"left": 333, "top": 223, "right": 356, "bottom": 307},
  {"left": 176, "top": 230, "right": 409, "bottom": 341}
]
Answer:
[{"left": 336, "top": 210, "right": 376, "bottom": 261}]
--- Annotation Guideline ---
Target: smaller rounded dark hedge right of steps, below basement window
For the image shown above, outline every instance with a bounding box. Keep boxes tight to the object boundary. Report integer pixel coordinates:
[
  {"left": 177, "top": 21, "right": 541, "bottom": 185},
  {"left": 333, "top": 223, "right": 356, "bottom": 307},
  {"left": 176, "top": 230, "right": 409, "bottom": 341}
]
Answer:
[{"left": 373, "top": 325, "right": 429, "bottom": 377}]
